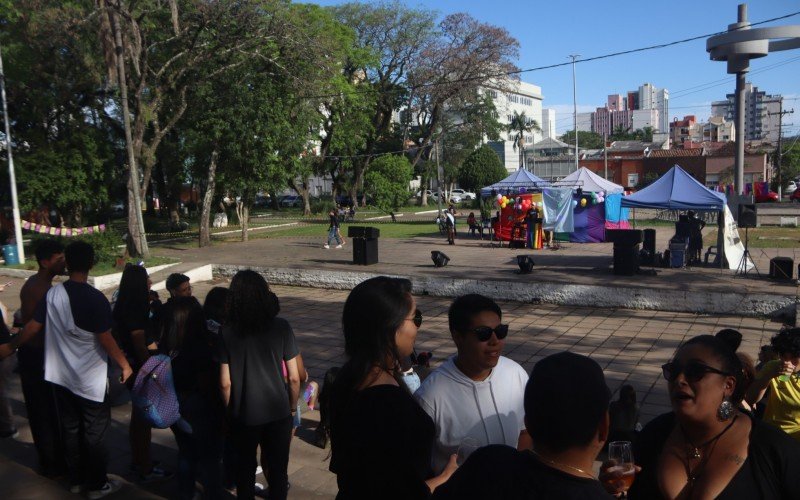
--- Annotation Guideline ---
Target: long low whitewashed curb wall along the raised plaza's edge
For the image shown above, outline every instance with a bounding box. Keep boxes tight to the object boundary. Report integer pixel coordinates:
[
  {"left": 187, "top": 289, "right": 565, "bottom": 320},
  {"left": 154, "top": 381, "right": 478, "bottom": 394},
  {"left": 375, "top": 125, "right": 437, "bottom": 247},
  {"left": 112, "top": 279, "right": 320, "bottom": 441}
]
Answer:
[{"left": 214, "top": 265, "right": 798, "bottom": 318}]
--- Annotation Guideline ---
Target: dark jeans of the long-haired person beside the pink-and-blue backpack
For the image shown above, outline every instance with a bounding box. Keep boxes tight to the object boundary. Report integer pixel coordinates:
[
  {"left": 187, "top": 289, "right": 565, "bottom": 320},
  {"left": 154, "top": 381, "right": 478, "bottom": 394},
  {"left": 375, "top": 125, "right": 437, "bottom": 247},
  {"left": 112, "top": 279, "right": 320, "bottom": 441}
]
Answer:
[{"left": 172, "top": 392, "right": 222, "bottom": 500}]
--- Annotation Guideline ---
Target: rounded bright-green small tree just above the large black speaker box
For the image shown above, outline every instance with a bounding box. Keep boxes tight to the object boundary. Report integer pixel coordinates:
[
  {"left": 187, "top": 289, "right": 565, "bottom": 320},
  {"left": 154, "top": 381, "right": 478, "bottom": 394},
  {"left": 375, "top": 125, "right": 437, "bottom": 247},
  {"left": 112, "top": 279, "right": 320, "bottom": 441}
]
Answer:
[{"left": 364, "top": 155, "right": 414, "bottom": 210}]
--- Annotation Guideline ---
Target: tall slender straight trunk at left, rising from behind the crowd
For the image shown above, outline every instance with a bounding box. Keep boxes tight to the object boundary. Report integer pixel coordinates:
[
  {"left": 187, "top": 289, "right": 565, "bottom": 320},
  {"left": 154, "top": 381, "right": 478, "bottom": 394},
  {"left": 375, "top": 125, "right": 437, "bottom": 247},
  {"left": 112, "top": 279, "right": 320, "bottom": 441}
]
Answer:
[{"left": 106, "top": 4, "right": 150, "bottom": 259}]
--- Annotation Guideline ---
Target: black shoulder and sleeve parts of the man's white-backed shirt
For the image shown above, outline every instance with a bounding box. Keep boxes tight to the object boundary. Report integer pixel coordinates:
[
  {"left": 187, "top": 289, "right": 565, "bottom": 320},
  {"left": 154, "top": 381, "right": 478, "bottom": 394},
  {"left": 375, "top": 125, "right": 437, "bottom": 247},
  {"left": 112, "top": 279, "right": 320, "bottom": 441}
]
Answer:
[{"left": 33, "top": 280, "right": 112, "bottom": 334}]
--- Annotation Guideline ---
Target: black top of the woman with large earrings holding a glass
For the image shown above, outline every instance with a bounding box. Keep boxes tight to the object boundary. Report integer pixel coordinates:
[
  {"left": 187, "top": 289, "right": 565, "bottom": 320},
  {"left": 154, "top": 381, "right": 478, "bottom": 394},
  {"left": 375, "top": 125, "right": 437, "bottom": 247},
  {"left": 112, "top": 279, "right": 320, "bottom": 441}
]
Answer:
[{"left": 628, "top": 412, "right": 800, "bottom": 500}]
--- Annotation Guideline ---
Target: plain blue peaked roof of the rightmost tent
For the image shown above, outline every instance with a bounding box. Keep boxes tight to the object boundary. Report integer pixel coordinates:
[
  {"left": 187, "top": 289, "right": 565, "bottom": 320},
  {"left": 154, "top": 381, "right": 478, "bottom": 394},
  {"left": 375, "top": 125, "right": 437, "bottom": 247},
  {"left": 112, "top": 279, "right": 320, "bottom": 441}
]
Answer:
[{"left": 622, "top": 165, "right": 726, "bottom": 210}]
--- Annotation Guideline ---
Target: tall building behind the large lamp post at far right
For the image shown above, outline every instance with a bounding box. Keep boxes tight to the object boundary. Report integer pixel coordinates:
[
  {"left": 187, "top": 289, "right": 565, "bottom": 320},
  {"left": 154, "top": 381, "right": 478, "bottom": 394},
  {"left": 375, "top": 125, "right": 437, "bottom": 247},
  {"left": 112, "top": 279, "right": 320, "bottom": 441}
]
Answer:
[{"left": 711, "top": 82, "right": 783, "bottom": 144}]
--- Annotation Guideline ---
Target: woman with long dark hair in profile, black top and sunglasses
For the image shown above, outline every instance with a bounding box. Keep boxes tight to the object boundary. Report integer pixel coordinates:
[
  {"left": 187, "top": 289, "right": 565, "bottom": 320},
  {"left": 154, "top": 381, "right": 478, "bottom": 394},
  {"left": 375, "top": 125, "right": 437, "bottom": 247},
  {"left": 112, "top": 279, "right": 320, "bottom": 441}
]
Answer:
[{"left": 330, "top": 276, "right": 456, "bottom": 500}]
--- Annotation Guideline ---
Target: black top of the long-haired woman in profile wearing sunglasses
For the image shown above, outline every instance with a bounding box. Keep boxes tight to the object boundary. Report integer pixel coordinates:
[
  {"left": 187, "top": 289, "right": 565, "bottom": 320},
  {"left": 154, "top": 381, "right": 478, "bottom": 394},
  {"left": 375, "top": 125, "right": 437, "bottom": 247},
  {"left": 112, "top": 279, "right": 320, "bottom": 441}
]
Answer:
[{"left": 330, "top": 385, "right": 436, "bottom": 500}]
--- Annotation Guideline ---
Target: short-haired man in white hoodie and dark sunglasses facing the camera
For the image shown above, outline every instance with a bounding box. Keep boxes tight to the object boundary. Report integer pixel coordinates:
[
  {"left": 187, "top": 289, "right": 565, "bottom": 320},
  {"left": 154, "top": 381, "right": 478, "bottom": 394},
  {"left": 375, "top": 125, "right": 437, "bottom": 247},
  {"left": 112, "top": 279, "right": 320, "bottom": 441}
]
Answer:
[{"left": 414, "top": 294, "right": 531, "bottom": 474}]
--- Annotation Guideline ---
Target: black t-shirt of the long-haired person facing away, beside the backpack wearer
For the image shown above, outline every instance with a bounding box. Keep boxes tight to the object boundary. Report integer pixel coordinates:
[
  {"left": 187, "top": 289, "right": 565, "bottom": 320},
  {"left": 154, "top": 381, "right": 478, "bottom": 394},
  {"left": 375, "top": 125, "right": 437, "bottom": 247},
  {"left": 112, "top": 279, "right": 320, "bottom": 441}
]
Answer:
[{"left": 218, "top": 318, "right": 299, "bottom": 425}]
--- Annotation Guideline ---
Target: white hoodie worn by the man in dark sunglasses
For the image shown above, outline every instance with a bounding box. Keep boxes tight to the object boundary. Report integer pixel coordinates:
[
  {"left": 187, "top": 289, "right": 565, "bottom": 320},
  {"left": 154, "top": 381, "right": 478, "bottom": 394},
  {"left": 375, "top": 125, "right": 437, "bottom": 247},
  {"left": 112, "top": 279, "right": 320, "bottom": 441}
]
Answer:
[{"left": 414, "top": 355, "right": 528, "bottom": 474}]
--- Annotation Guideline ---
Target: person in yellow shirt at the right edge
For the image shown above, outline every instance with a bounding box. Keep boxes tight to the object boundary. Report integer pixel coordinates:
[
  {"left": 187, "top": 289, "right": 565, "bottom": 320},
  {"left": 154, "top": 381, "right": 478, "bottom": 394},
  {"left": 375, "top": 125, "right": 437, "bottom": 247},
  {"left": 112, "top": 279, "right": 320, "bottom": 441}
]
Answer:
[{"left": 745, "top": 328, "right": 800, "bottom": 441}]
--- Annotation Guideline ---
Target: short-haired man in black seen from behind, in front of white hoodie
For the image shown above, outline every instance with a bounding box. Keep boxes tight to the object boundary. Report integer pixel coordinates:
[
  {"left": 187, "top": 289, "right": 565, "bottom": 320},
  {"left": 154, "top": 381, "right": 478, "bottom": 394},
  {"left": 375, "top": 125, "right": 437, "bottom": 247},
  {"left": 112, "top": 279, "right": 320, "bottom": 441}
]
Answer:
[{"left": 433, "top": 352, "right": 611, "bottom": 500}]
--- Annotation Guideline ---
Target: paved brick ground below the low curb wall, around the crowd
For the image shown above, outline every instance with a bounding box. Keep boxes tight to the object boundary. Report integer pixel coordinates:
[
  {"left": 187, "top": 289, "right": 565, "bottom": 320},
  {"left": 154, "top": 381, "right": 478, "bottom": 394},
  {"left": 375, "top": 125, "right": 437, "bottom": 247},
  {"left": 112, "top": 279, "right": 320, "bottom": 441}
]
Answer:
[{"left": 0, "top": 279, "right": 780, "bottom": 500}]
